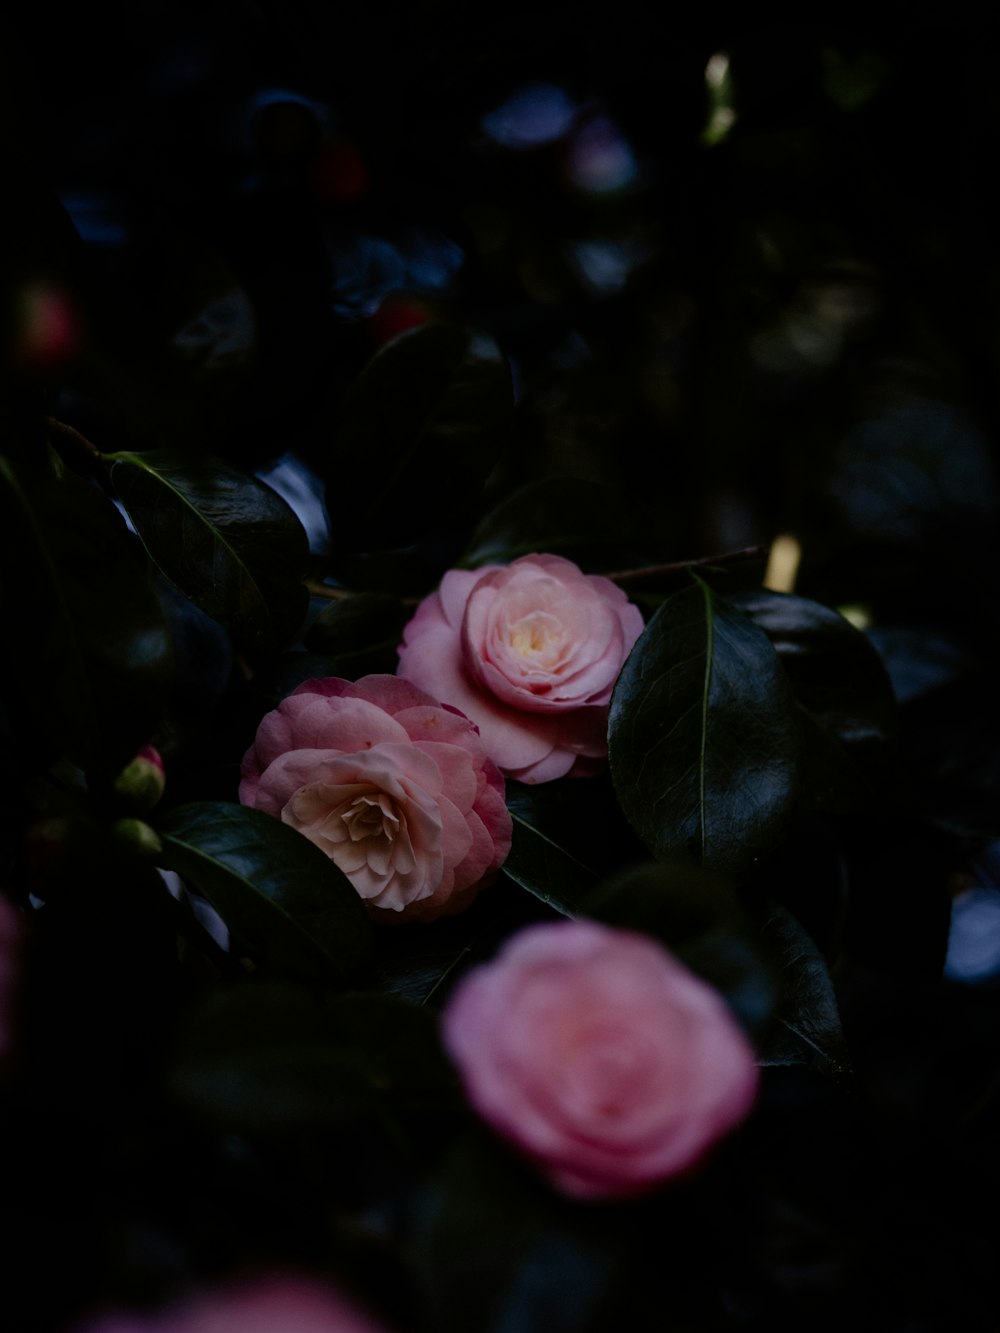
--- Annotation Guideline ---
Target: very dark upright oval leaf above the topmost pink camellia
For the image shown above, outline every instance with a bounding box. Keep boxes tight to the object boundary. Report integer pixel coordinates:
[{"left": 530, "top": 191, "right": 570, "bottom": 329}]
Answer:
[{"left": 327, "top": 324, "right": 513, "bottom": 552}]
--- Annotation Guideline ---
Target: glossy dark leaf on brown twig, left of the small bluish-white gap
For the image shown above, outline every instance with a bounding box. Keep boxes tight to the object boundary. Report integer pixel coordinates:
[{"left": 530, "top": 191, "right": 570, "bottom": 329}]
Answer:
[{"left": 108, "top": 449, "right": 309, "bottom": 649}]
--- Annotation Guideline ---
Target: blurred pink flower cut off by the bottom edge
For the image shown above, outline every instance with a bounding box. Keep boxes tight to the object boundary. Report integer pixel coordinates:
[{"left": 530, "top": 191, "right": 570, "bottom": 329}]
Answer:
[{"left": 73, "top": 1274, "right": 387, "bottom": 1333}]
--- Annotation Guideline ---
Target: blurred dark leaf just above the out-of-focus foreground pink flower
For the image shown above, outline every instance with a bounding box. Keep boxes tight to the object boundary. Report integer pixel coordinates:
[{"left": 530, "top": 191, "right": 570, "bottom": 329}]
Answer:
[{"left": 579, "top": 861, "right": 777, "bottom": 1032}]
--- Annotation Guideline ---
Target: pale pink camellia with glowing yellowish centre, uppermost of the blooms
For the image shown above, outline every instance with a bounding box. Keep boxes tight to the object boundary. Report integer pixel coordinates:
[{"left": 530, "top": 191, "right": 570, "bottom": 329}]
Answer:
[{"left": 397, "top": 555, "right": 643, "bottom": 782}]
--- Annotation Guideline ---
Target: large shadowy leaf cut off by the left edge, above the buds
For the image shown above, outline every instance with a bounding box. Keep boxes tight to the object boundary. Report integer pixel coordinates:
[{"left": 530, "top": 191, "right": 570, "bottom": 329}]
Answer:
[{"left": 0, "top": 456, "right": 172, "bottom": 772}]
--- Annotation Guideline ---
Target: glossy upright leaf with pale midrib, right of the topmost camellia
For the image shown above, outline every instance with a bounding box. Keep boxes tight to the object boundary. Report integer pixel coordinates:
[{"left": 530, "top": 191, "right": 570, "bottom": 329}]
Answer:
[{"left": 608, "top": 580, "right": 797, "bottom": 880}]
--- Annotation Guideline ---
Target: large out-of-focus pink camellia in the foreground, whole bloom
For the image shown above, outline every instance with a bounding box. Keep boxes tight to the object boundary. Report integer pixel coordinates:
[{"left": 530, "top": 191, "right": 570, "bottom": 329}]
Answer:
[{"left": 441, "top": 920, "right": 757, "bottom": 1198}]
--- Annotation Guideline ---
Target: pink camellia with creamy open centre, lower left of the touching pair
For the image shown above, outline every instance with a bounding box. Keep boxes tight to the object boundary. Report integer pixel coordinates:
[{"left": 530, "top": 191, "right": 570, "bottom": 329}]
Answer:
[{"left": 240, "top": 676, "right": 511, "bottom": 921}]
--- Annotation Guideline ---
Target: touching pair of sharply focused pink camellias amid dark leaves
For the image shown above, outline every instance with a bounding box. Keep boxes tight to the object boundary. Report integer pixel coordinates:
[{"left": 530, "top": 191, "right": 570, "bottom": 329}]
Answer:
[{"left": 240, "top": 555, "right": 643, "bottom": 921}]
